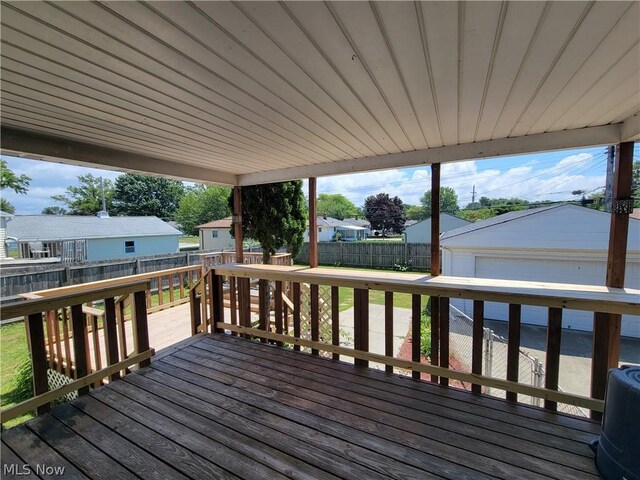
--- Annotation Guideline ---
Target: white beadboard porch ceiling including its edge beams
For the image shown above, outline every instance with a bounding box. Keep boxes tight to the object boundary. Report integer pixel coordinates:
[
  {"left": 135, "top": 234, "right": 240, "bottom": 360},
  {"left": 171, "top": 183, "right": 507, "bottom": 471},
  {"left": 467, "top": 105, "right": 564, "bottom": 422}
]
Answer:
[{"left": 1, "top": 1, "right": 640, "bottom": 184}]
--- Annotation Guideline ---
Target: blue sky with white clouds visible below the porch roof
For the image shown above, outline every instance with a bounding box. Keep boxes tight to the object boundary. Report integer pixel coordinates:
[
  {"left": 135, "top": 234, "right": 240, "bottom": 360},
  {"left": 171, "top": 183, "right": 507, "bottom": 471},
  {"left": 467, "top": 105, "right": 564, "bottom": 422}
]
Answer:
[{"left": 2, "top": 144, "right": 640, "bottom": 215}]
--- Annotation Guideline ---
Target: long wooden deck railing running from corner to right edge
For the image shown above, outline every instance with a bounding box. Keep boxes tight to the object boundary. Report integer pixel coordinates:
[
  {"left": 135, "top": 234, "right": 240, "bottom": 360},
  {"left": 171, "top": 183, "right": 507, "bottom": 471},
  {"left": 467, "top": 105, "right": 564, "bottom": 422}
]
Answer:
[{"left": 192, "top": 265, "right": 640, "bottom": 412}]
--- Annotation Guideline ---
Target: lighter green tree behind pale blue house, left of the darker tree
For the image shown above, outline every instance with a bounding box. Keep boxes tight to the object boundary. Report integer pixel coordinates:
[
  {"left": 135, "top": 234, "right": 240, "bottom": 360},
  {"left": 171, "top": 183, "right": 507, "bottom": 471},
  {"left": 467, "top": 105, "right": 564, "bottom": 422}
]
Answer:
[{"left": 51, "top": 173, "right": 113, "bottom": 215}]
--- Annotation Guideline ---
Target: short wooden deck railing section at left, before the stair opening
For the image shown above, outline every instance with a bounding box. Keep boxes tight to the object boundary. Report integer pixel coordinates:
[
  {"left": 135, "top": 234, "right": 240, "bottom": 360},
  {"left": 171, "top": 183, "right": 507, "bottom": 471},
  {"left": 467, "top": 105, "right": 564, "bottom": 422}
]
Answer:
[{"left": 0, "top": 281, "right": 154, "bottom": 423}]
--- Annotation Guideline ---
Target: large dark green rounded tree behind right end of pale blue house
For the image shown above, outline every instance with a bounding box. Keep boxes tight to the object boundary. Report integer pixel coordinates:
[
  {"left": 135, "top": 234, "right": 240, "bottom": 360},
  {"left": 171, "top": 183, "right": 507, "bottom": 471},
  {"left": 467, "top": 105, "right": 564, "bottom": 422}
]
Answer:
[{"left": 111, "top": 173, "right": 184, "bottom": 218}]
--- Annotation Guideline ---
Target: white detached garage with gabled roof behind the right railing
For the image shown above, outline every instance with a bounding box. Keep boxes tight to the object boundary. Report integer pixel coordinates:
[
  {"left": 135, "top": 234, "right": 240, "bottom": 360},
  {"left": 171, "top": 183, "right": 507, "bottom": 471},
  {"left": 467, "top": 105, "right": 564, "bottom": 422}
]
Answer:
[{"left": 440, "top": 205, "right": 640, "bottom": 337}]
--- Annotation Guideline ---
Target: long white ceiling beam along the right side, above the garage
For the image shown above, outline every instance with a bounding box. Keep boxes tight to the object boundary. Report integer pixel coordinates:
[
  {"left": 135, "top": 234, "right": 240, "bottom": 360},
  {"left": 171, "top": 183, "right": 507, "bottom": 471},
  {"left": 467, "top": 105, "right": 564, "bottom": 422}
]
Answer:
[{"left": 238, "top": 124, "right": 621, "bottom": 185}]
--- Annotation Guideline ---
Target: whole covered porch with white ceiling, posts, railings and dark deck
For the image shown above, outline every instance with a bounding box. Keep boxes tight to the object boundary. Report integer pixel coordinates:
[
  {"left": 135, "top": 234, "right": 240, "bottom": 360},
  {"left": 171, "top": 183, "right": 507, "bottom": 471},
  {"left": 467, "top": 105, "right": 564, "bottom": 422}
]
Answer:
[{"left": 0, "top": 2, "right": 640, "bottom": 479}]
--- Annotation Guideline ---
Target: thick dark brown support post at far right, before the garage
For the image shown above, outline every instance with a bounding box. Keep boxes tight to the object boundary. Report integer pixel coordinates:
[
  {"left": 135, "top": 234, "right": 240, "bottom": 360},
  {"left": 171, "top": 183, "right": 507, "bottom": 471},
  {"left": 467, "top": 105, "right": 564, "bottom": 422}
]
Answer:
[{"left": 591, "top": 142, "right": 634, "bottom": 419}]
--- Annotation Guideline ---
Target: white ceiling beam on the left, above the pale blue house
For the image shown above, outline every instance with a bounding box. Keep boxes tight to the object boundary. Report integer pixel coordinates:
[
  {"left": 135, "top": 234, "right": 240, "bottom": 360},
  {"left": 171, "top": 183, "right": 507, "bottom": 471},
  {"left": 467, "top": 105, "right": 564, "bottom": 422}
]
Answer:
[{"left": 0, "top": 127, "right": 237, "bottom": 185}]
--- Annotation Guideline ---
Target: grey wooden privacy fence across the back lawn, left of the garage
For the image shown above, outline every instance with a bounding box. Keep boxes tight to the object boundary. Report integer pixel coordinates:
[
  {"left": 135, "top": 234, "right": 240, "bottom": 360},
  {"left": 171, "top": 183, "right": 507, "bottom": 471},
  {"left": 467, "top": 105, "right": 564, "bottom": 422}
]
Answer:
[{"left": 295, "top": 242, "right": 431, "bottom": 271}]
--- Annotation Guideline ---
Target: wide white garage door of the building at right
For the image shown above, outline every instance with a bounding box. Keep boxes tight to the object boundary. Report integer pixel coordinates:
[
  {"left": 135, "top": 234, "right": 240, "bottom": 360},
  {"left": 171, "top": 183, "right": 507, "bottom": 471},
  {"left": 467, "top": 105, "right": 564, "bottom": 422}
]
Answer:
[{"left": 475, "top": 256, "right": 640, "bottom": 337}]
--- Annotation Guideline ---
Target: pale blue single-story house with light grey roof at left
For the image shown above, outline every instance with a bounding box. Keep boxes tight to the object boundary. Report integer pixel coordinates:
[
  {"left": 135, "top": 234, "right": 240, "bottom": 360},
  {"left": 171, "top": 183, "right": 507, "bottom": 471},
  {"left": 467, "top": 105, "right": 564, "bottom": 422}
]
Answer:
[{"left": 7, "top": 215, "right": 181, "bottom": 261}]
